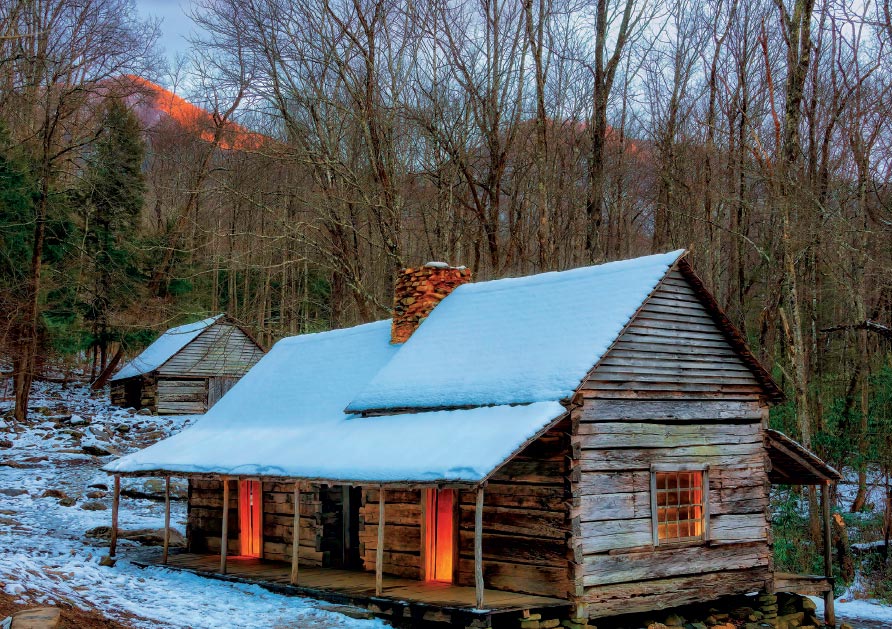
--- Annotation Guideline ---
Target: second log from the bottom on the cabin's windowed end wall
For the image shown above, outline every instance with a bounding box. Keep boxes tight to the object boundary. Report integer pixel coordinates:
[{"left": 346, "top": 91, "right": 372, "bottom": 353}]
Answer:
[{"left": 583, "top": 540, "right": 770, "bottom": 587}]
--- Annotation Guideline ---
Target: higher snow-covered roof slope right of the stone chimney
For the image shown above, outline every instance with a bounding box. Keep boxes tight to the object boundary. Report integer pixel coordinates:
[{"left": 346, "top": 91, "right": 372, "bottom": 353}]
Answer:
[{"left": 347, "top": 250, "right": 684, "bottom": 412}]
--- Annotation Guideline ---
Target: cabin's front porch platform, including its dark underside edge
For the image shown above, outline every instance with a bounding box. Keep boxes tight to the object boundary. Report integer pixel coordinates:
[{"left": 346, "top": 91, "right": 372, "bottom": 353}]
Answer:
[{"left": 131, "top": 550, "right": 570, "bottom": 627}]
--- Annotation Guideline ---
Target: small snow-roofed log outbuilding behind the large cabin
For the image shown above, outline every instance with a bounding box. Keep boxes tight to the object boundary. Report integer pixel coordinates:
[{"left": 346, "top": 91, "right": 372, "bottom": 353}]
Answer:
[{"left": 109, "top": 314, "right": 264, "bottom": 415}]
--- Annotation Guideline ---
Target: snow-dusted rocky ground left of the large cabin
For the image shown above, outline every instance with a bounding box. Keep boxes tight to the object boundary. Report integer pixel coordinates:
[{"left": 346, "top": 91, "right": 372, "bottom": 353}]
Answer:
[{"left": 0, "top": 383, "right": 385, "bottom": 629}]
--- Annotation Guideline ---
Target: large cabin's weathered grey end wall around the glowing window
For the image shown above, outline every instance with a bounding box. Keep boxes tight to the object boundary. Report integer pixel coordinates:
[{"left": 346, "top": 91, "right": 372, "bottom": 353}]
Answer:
[{"left": 572, "top": 272, "right": 771, "bottom": 617}]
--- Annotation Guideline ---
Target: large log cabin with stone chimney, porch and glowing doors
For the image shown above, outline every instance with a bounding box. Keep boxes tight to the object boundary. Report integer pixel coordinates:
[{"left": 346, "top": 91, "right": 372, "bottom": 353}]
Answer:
[{"left": 105, "top": 251, "right": 839, "bottom": 627}]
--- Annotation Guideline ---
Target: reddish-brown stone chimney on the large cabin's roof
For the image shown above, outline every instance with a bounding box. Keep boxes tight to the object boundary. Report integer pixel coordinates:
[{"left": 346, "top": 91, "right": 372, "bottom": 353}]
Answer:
[{"left": 390, "top": 262, "right": 471, "bottom": 344}]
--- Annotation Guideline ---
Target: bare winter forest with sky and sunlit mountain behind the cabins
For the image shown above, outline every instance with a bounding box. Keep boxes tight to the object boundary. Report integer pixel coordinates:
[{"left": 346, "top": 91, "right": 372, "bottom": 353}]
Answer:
[{"left": 0, "top": 0, "right": 892, "bottom": 594}]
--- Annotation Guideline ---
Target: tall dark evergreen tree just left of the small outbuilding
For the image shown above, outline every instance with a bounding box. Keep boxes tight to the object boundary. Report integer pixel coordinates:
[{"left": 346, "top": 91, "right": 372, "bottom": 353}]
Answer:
[{"left": 83, "top": 98, "right": 146, "bottom": 369}]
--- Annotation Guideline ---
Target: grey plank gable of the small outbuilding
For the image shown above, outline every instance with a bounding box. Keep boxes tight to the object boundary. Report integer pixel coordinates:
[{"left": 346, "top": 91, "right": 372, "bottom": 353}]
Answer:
[{"left": 158, "top": 322, "right": 263, "bottom": 377}]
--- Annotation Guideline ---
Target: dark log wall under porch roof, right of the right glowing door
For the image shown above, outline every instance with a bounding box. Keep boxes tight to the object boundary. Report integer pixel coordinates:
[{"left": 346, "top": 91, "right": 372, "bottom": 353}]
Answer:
[{"left": 457, "top": 420, "right": 572, "bottom": 598}]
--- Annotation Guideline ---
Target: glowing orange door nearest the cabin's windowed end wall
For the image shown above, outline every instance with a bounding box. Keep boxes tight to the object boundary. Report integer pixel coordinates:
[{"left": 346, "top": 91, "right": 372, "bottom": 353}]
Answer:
[{"left": 424, "top": 489, "right": 458, "bottom": 583}]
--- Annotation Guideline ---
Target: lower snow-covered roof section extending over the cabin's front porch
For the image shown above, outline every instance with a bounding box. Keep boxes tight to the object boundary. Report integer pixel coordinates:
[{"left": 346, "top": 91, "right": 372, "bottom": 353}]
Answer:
[{"left": 105, "top": 321, "right": 566, "bottom": 482}]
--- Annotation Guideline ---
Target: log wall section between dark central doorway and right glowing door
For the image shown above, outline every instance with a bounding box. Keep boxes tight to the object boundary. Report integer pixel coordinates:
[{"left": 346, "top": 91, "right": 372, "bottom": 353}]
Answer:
[{"left": 359, "top": 489, "right": 422, "bottom": 579}]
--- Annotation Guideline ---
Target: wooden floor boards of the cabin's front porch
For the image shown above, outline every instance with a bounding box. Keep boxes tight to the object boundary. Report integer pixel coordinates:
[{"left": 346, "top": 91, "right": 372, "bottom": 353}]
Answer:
[{"left": 133, "top": 552, "right": 570, "bottom": 615}]
